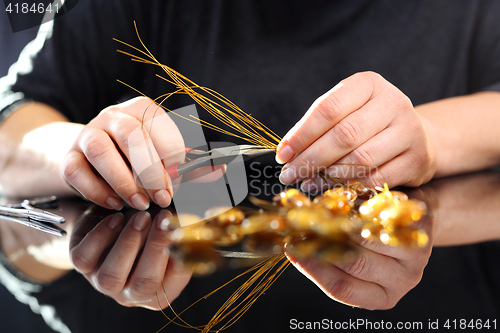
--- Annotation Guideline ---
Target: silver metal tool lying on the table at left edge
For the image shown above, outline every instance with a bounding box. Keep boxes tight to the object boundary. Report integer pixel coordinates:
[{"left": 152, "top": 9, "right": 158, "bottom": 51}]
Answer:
[{"left": 0, "top": 196, "right": 66, "bottom": 236}]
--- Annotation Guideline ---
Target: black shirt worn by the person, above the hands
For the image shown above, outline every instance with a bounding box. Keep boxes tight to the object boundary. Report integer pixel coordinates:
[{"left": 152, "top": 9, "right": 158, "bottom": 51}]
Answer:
[{"left": 0, "top": 0, "right": 500, "bottom": 135}]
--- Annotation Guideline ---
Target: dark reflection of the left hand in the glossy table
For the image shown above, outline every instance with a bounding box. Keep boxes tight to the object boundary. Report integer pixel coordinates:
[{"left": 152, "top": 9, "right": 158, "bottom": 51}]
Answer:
[{"left": 70, "top": 211, "right": 191, "bottom": 310}]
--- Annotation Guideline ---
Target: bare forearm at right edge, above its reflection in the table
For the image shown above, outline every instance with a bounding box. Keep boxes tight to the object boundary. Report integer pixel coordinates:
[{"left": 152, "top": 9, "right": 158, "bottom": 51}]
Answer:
[{"left": 415, "top": 92, "right": 500, "bottom": 177}]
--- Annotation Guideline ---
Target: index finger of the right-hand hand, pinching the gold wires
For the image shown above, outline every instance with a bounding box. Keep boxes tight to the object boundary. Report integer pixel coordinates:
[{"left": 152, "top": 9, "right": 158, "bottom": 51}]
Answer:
[{"left": 276, "top": 73, "right": 379, "bottom": 163}]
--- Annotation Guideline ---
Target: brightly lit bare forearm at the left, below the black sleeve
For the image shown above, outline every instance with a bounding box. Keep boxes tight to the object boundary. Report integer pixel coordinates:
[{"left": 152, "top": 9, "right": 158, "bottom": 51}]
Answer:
[{"left": 0, "top": 103, "right": 83, "bottom": 196}]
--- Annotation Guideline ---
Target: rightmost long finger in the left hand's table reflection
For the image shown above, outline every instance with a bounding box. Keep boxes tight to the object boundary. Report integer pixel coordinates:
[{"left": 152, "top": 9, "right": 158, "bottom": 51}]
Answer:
[{"left": 126, "top": 210, "right": 172, "bottom": 300}]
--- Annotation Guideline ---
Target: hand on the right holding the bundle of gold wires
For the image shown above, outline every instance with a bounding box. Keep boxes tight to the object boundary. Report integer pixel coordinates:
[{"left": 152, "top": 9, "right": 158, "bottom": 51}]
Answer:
[{"left": 277, "top": 72, "right": 436, "bottom": 191}]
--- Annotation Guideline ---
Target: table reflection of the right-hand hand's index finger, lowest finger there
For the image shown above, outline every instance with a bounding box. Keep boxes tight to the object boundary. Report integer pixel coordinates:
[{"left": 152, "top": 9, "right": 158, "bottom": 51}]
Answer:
[{"left": 289, "top": 257, "right": 396, "bottom": 310}]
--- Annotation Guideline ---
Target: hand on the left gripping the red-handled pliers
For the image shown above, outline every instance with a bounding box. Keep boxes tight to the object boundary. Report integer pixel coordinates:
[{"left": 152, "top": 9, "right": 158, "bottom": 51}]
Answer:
[{"left": 62, "top": 97, "right": 185, "bottom": 210}]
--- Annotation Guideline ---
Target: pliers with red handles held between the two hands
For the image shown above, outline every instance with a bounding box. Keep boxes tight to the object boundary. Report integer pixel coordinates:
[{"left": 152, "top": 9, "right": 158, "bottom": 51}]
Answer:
[{"left": 166, "top": 145, "right": 275, "bottom": 179}]
